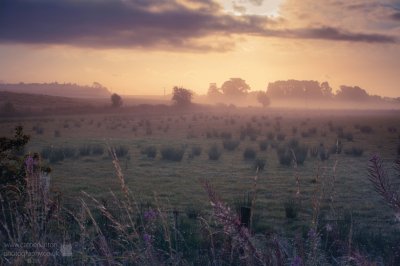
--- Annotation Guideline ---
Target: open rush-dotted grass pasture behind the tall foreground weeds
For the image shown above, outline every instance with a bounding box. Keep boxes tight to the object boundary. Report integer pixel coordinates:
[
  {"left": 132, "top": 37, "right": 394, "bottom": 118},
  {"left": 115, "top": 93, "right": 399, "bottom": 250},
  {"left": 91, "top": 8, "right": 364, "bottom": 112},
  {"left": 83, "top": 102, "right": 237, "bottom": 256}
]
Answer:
[{"left": 0, "top": 109, "right": 400, "bottom": 237}]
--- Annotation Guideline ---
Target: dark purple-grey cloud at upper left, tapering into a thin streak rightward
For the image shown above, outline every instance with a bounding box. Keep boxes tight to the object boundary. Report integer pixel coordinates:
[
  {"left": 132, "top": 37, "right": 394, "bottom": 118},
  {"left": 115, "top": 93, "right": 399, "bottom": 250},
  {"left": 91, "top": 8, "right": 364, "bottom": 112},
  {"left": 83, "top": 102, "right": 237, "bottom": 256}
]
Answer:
[{"left": 0, "top": 0, "right": 395, "bottom": 51}]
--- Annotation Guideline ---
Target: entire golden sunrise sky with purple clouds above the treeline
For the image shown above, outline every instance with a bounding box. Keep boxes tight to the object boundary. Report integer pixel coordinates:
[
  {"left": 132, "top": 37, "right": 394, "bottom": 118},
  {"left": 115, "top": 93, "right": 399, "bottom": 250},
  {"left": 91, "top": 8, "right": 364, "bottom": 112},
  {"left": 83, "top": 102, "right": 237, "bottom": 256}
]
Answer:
[{"left": 0, "top": 0, "right": 400, "bottom": 97}]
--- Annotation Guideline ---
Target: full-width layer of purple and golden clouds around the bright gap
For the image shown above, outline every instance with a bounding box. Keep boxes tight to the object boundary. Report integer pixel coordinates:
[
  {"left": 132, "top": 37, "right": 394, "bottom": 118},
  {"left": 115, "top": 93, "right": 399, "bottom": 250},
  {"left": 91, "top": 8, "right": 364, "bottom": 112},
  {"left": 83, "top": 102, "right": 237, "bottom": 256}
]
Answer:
[{"left": 0, "top": 0, "right": 400, "bottom": 51}]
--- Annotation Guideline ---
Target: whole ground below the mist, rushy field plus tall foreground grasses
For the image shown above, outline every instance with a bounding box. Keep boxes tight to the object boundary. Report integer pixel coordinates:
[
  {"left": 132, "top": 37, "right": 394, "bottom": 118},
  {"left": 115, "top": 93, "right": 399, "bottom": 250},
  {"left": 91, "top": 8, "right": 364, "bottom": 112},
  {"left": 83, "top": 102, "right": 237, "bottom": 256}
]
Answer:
[{"left": 1, "top": 108, "right": 400, "bottom": 265}]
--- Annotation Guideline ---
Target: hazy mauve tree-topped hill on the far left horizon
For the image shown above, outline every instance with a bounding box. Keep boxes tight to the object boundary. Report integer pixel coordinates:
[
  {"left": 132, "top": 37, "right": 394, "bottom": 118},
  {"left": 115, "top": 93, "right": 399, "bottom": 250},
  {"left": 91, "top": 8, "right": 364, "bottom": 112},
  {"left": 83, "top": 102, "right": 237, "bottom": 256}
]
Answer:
[{"left": 0, "top": 82, "right": 111, "bottom": 98}]
